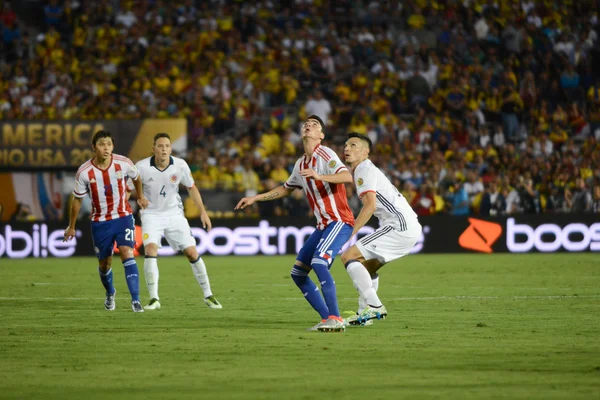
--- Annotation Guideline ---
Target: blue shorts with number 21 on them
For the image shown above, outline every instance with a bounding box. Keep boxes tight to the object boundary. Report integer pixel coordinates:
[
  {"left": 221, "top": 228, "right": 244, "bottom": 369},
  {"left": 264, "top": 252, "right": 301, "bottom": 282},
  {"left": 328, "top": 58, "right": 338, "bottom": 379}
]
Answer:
[{"left": 92, "top": 215, "right": 135, "bottom": 260}]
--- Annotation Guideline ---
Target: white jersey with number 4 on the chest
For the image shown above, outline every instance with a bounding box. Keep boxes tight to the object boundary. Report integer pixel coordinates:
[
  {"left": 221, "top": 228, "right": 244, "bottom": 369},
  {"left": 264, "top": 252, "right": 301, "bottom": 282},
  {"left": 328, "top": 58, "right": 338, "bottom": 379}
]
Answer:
[{"left": 136, "top": 156, "right": 194, "bottom": 216}]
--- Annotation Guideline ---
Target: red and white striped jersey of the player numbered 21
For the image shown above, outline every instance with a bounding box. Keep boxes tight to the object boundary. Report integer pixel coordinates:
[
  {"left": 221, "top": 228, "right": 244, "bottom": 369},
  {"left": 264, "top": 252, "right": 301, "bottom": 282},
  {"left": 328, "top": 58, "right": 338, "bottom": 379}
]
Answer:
[{"left": 73, "top": 154, "right": 138, "bottom": 222}]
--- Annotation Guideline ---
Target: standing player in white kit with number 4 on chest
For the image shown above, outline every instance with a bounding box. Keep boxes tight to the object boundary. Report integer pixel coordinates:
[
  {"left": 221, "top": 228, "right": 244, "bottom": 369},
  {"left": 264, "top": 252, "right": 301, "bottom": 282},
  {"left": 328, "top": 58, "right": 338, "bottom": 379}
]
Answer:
[{"left": 136, "top": 133, "right": 222, "bottom": 310}]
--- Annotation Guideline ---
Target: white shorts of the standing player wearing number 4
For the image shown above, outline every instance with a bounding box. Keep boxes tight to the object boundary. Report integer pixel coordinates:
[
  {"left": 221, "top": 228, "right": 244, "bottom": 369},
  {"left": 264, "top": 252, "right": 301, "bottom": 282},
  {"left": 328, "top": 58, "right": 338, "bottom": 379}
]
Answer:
[{"left": 142, "top": 214, "right": 196, "bottom": 251}]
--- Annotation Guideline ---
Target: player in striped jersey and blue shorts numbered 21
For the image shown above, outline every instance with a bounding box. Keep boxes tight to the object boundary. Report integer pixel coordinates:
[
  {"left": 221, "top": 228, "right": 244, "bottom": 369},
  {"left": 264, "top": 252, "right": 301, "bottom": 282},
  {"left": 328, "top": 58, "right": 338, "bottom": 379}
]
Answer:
[{"left": 64, "top": 130, "right": 148, "bottom": 312}]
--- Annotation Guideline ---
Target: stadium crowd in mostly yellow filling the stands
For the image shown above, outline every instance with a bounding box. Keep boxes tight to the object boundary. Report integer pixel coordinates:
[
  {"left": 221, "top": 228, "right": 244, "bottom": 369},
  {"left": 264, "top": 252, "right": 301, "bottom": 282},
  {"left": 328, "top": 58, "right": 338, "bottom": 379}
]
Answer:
[{"left": 0, "top": 0, "right": 600, "bottom": 217}]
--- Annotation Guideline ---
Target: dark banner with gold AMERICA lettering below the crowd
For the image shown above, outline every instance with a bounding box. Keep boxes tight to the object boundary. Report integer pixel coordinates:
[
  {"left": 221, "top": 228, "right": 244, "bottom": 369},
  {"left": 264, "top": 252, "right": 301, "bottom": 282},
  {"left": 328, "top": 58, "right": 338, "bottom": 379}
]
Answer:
[{"left": 0, "top": 119, "right": 187, "bottom": 171}]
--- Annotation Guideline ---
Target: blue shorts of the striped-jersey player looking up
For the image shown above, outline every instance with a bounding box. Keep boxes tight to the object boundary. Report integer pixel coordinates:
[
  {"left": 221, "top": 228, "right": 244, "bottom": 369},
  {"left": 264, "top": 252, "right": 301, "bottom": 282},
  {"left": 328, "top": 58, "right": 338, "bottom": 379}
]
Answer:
[{"left": 296, "top": 222, "right": 352, "bottom": 268}]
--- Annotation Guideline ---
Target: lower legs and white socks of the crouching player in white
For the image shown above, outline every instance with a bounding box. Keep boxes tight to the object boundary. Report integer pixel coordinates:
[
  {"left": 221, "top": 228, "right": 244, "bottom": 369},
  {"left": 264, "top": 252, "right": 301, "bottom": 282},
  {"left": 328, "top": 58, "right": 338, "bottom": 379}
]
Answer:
[{"left": 342, "top": 245, "right": 387, "bottom": 325}]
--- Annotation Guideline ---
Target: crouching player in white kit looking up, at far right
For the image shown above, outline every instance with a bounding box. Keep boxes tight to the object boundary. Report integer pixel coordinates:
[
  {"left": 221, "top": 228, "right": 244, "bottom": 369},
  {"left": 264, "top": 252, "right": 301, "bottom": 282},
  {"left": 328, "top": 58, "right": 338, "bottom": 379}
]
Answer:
[{"left": 342, "top": 133, "right": 422, "bottom": 325}]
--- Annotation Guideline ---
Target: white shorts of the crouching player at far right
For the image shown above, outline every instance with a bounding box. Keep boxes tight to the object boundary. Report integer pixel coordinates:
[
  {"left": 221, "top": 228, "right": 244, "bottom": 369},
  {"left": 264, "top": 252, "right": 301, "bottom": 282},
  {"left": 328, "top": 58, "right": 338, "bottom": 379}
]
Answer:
[{"left": 356, "top": 225, "right": 422, "bottom": 264}]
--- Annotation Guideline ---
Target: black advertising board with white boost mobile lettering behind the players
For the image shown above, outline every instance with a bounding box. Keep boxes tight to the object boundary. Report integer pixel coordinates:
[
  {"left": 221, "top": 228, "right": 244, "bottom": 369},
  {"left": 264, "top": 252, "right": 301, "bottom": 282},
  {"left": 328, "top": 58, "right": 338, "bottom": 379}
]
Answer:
[{"left": 0, "top": 214, "right": 600, "bottom": 258}]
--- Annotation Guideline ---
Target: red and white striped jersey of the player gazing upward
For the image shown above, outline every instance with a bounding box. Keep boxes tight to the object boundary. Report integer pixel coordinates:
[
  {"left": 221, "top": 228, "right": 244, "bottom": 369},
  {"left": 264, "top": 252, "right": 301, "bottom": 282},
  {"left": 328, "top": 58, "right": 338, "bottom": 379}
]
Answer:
[{"left": 284, "top": 145, "right": 354, "bottom": 229}]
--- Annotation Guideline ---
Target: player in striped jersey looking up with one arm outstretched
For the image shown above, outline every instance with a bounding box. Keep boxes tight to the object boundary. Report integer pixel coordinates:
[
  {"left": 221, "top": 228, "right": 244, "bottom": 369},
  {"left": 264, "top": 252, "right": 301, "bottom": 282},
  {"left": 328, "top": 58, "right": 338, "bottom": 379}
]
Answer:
[{"left": 235, "top": 115, "right": 354, "bottom": 332}]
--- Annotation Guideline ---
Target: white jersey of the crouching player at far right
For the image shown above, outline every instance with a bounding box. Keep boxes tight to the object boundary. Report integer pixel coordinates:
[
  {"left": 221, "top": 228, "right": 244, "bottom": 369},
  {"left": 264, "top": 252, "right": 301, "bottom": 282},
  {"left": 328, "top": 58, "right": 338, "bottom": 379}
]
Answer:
[{"left": 354, "top": 160, "right": 421, "bottom": 232}]
